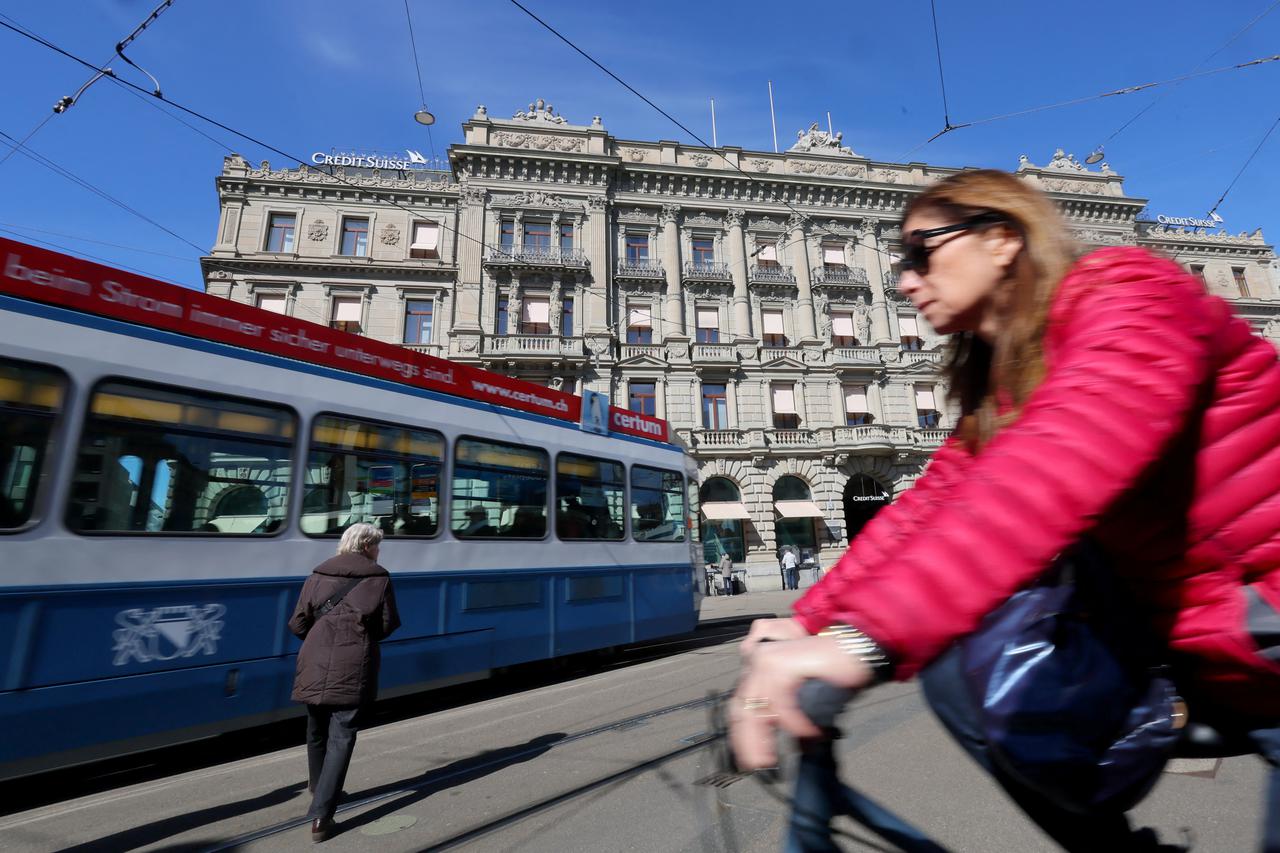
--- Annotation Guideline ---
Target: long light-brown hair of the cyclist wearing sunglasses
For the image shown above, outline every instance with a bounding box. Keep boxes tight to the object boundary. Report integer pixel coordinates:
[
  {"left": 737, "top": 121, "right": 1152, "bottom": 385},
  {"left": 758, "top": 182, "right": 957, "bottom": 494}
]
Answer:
[{"left": 902, "top": 169, "right": 1078, "bottom": 452}]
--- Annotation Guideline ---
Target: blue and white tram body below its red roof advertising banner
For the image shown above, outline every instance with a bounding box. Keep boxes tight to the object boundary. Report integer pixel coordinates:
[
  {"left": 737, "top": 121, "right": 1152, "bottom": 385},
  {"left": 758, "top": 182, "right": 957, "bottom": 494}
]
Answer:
[{"left": 0, "top": 239, "right": 700, "bottom": 779}]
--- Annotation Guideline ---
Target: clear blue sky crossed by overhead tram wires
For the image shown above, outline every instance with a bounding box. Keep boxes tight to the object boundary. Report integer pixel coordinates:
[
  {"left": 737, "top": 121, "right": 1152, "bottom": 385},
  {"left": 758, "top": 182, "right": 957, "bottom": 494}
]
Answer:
[{"left": 0, "top": 0, "right": 1280, "bottom": 287}]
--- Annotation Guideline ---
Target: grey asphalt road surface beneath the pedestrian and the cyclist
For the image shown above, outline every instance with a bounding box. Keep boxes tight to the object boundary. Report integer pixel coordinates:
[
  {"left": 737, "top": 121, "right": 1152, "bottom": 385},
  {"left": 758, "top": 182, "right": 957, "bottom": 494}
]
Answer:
[{"left": 0, "top": 593, "right": 1265, "bottom": 853}]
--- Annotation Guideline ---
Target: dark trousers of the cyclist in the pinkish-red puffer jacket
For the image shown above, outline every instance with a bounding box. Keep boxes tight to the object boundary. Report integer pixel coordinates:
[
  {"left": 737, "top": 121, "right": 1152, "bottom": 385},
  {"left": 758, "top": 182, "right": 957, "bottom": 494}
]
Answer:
[{"left": 920, "top": 647, "right": 1280, "bottom": 853}]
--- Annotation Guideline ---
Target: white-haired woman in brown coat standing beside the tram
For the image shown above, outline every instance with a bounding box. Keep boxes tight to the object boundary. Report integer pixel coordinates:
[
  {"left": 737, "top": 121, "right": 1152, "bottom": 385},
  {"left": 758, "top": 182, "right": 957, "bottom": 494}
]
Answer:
[{"left": 289, "top": 524, "right": 399, "bottom": 841}]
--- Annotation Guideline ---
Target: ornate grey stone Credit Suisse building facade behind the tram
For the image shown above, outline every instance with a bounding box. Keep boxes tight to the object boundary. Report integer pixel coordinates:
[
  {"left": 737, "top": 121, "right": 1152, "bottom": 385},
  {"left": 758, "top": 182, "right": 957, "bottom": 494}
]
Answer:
[{"left": 202, "top": 101, "right": 1280, "bottom": 589}]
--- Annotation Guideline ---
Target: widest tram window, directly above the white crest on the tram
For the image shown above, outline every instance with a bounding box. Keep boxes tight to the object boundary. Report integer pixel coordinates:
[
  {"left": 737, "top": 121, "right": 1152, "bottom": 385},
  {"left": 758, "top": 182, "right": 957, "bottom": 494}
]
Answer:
[{"left": 67, "top": 380, "right": 296, "bottom": 535}]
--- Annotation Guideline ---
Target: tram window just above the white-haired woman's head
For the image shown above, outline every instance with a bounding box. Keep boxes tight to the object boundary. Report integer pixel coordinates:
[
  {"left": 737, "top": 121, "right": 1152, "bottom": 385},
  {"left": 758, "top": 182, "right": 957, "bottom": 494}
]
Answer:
[{"left": 302, "top": 415, "right": 444, "bottom": 537}]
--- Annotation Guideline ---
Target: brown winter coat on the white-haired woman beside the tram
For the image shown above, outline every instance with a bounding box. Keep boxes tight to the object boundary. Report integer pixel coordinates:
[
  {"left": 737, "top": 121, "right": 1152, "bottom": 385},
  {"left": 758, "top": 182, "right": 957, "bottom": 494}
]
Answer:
[{"left": 289, "top": 553, "right": 399, "bottom": 706}]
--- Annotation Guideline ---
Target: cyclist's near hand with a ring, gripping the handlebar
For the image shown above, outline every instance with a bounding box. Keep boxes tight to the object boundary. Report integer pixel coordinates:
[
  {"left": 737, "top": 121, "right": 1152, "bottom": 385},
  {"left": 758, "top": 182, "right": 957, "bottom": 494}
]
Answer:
[{"left": 728, "top": 630, "right": 872, "bottom": 770}]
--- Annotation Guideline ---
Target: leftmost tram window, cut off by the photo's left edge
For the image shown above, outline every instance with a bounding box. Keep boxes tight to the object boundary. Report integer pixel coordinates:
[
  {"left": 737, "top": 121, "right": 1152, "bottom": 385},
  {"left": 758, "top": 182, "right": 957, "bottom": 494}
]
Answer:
[{"left": 0, "top": 359, "right": 67, "bottom": 530}]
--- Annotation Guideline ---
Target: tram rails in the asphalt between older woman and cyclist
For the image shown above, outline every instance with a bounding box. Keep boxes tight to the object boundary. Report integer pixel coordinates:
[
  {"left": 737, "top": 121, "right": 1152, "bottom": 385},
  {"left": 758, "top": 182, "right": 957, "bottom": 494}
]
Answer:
[{"left": 204, "top": 690, "right": 730, "bottom": 853}]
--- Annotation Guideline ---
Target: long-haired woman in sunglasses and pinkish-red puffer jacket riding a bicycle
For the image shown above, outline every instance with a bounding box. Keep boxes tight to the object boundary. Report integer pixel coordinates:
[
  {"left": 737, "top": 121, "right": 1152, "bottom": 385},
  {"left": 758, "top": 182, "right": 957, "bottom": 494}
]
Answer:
[{"left": 731, "top": 170, "right": 1280, "bottom": 849}]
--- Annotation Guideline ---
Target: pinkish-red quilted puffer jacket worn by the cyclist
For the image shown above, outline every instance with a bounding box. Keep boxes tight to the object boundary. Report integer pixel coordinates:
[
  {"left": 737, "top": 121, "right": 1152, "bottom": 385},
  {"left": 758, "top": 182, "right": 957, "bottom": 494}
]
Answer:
[{"left": 795, "top": 248, "right": 1280, "bottom": 715}]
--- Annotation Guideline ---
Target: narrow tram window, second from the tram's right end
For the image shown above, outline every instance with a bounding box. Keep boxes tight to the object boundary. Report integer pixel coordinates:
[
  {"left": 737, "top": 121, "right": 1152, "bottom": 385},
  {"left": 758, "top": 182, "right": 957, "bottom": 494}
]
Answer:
[{"left": 556, "top": 453, "right": 626, "bottom": 542}]
